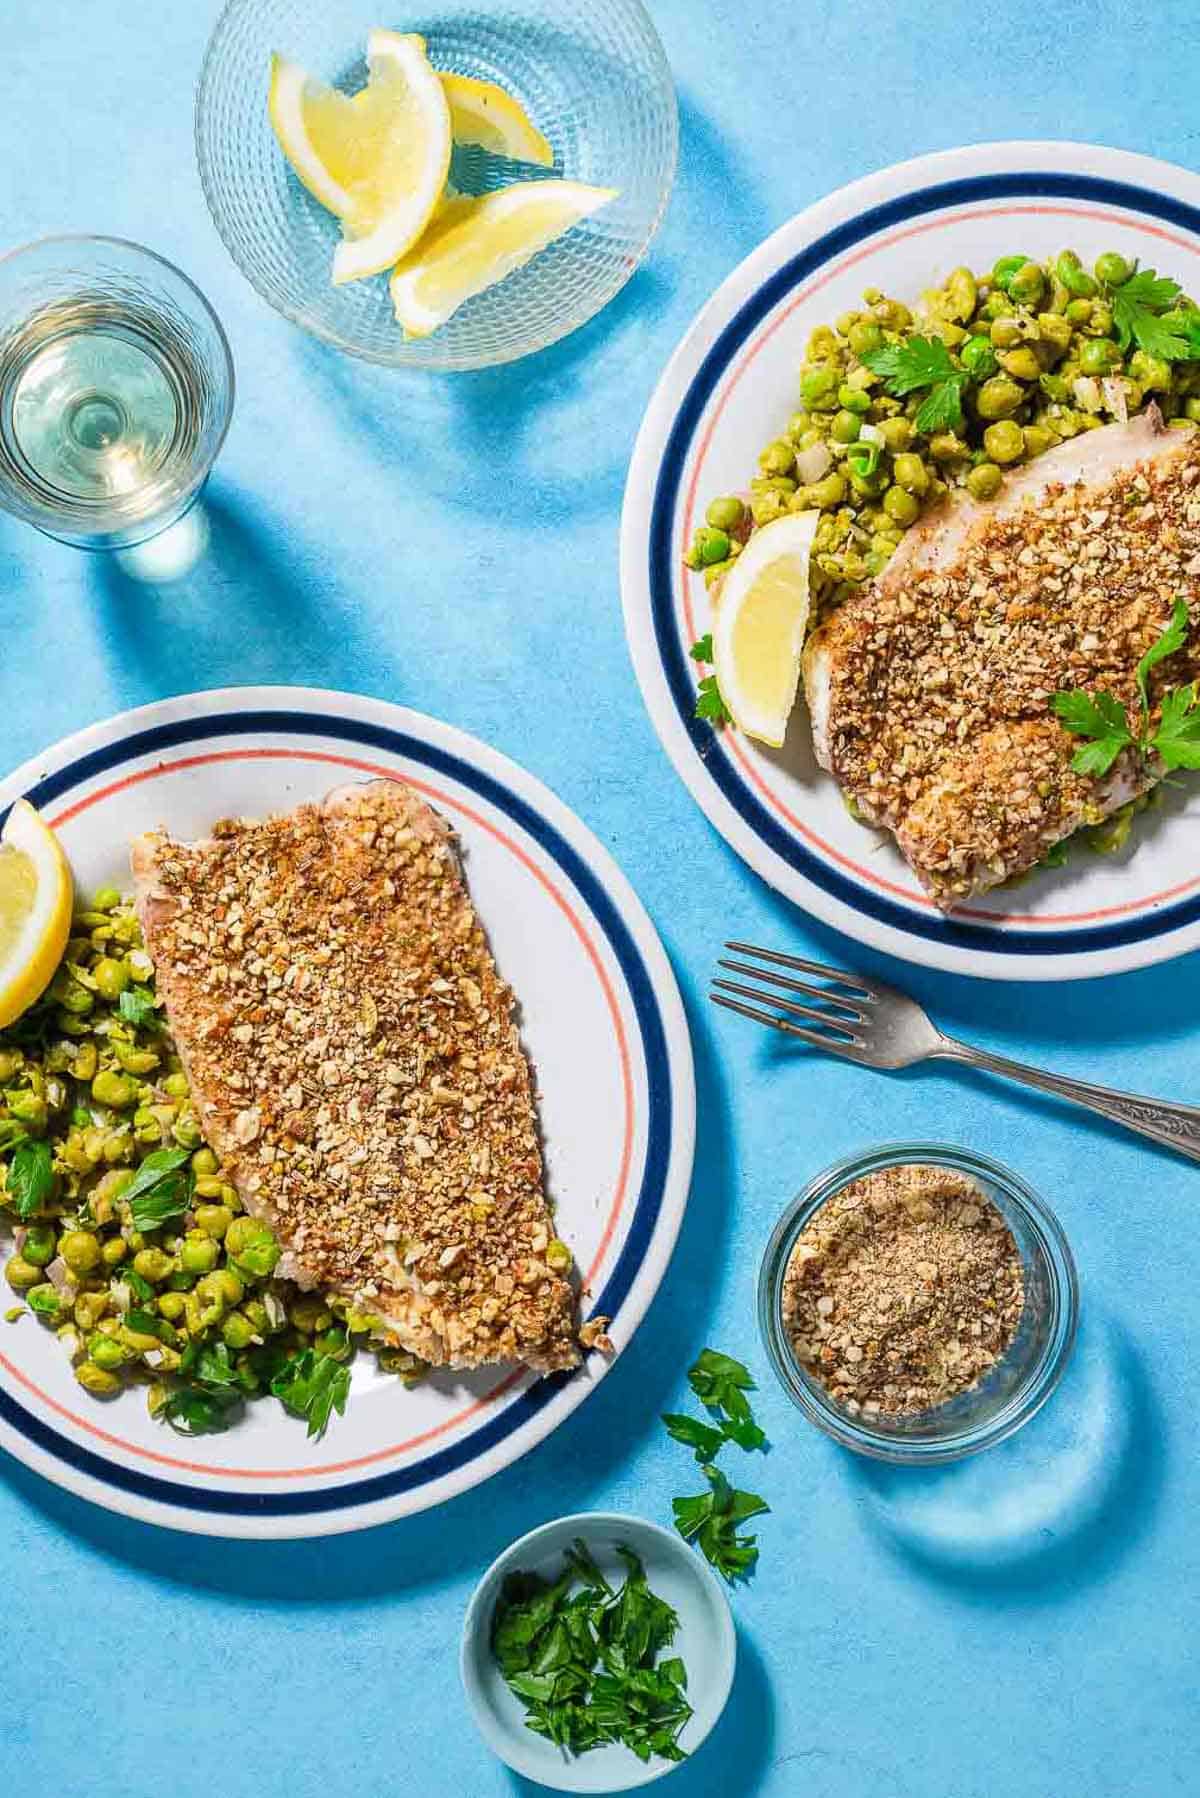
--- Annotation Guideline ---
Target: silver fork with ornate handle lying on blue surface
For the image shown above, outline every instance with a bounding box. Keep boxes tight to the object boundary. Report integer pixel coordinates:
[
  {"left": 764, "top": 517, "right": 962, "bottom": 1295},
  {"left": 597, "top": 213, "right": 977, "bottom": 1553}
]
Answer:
[{"left": 709, "top": 942, "right": 1200, "bottom": 1162}]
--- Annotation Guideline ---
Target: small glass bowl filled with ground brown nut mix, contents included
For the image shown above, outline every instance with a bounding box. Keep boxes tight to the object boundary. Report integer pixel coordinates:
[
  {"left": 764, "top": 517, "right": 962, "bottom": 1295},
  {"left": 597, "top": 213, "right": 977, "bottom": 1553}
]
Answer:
[{"left": 759, "top": 1142, "right": 1079, "bottom": 1465}]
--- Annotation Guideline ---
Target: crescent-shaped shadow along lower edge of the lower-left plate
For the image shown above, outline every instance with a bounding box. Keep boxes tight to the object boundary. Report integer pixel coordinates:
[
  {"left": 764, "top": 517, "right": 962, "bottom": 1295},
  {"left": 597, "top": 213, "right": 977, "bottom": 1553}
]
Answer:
[{"left": 0, "top": 985, "right": 734, "bottom": 1606}]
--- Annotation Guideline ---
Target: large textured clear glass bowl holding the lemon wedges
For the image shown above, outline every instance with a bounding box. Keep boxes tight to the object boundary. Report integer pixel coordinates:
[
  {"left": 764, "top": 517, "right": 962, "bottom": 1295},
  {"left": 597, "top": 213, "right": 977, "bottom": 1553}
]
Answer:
[{"left": 196, "top": 0, "right": 678, "bottom": 369}]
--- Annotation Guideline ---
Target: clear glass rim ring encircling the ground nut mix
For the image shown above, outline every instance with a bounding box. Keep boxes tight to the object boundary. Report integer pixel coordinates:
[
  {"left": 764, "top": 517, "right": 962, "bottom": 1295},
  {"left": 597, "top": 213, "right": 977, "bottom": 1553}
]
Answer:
[{"left": 757, "top": 1140, "right": 1079, "bottom": 1465}]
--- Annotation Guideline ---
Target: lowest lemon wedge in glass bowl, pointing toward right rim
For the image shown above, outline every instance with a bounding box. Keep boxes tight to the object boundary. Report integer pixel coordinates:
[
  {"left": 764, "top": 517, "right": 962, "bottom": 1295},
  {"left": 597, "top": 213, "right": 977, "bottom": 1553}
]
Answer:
[{"left": 390, "top": 182, "right": 617, "bottom": 336}]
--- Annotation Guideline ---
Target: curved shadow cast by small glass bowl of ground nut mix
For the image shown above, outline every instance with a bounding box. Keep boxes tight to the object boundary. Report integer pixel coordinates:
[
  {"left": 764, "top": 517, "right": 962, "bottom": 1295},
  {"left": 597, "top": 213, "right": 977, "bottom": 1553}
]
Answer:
[{"left": 849, "top": 1318, "right": 1166, "bottom": 1609}]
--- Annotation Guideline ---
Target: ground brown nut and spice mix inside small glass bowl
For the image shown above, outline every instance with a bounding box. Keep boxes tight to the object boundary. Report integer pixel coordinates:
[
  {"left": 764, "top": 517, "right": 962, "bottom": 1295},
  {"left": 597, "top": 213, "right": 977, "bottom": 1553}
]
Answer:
[{"left": 783, "top": 1165, "right": 1025, "bottom": 1417}]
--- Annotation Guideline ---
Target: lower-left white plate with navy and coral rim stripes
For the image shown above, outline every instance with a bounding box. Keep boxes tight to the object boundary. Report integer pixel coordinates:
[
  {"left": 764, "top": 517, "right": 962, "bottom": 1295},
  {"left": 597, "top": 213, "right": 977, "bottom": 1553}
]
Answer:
[{"left": 0, "top": 687, "right": 694, "bottom": 1537}]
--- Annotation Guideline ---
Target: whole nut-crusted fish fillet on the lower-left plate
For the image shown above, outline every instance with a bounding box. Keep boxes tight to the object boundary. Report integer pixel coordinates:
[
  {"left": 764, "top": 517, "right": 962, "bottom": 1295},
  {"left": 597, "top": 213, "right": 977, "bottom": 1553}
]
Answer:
[{"left": 133, "top": 780, "right": 579, "bottom": 1368}]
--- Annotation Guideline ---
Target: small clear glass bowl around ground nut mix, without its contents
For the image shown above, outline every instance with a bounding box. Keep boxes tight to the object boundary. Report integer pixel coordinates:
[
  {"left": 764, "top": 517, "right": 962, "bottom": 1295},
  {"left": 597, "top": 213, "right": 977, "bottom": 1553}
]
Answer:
[{"left": 759, "top": 1142, "right": 1079, "bottom": 1465}]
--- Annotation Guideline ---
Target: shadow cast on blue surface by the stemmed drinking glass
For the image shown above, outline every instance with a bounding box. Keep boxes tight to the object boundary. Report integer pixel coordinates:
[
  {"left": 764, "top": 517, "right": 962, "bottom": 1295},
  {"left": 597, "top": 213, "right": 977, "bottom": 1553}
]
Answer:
[{"left": 86, "top": 484, "right": 408, "bottom": 698}]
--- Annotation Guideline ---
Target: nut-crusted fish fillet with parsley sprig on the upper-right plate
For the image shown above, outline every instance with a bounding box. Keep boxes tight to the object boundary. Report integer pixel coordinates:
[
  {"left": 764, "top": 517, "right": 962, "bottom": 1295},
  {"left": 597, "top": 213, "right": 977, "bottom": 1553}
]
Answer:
[{"left": 804, "top": 408, "right": 1200, "bottom": 910}]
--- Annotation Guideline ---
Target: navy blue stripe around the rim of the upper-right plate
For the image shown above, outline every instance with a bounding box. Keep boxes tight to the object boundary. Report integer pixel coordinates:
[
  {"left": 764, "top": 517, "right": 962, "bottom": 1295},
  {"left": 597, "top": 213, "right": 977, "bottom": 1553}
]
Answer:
[{"left": 649, "top": 171, "right": 1200, "bottom": 955}]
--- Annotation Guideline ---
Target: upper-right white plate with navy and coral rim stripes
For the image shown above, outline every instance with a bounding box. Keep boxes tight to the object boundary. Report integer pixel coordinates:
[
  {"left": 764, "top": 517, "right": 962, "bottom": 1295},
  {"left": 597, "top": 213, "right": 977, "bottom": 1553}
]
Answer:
[{"left": 621, "top": 142, "right": 1200, "bottom": 980}]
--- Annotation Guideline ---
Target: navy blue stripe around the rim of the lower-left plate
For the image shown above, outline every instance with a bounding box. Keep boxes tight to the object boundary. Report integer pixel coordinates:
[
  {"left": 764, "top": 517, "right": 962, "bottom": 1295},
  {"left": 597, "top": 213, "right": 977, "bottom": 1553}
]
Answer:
[{"left": 0, "top": 712, "right": 673, "bottom": 1518}]
